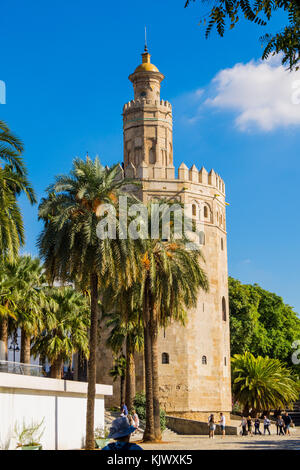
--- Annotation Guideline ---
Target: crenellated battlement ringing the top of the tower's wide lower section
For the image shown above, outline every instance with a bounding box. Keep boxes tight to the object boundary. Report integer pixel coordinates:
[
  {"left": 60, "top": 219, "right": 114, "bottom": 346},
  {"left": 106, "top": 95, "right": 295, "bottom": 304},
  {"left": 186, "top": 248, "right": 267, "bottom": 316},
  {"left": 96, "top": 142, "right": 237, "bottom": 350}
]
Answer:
[{"left": 125, "top": 161, "right": 225, "bottom": 195}]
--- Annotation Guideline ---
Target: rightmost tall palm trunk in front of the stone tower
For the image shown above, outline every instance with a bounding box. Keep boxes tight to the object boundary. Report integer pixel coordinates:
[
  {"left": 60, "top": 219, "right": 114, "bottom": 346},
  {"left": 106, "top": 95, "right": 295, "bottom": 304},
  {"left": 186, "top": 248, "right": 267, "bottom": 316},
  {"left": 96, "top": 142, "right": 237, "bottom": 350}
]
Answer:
[{"left": 150, "top": 306, "right": 161, "bottom": 441}]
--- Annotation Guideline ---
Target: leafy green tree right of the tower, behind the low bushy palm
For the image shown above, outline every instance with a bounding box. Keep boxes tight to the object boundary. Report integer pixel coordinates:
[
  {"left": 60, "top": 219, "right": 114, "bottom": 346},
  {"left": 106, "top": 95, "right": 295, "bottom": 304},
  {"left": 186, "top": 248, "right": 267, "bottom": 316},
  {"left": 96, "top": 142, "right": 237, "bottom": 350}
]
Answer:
[{"left": 229, "top": 278, "right": 300, "bottom": 367}]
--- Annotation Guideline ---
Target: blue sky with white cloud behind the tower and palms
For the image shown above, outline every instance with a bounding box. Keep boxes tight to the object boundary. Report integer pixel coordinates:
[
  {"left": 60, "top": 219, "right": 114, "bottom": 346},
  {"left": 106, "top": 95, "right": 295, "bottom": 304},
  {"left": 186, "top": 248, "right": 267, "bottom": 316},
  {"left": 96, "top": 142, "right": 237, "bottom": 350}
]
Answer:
[{"left": 0, "top": 0, "right": 300, "bottom": 312}]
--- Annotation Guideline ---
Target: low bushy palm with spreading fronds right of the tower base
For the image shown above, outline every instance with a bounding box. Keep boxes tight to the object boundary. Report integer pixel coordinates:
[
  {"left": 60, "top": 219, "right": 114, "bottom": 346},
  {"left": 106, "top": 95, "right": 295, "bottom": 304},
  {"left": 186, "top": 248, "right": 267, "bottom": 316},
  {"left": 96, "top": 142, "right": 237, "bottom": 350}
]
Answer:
[{"left": 231, "top": 352, "right": 300, "bottom": 416}]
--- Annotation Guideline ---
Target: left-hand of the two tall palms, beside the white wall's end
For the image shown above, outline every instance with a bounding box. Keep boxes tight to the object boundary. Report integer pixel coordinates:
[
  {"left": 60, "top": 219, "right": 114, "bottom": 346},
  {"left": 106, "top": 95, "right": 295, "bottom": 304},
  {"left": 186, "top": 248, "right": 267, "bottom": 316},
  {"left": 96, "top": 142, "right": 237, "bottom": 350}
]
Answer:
[{"left": 38, "top": 157, "right": 136, "bottom": 449}]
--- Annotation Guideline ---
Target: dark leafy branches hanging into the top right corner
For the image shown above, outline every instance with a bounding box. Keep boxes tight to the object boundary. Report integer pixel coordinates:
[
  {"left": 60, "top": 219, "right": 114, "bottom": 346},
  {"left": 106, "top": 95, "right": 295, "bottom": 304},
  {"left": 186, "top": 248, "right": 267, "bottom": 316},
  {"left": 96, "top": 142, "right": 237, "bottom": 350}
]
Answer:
[{"left": 185, "top": 0, "right": 300, "bottom": 70}]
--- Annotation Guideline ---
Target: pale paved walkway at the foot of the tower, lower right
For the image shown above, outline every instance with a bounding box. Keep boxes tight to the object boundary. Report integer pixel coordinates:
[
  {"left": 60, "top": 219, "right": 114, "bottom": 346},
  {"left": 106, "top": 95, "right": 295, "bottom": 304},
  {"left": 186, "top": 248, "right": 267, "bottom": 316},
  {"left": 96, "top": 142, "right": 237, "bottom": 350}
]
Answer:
[{"left": 132, "top": 428, "right": 300, "bottom": 450}]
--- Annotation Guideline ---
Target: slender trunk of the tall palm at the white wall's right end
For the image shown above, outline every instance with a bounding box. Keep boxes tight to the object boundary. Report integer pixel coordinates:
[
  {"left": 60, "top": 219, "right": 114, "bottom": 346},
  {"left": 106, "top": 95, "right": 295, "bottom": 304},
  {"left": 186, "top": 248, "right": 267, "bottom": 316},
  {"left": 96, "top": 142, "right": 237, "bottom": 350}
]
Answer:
[{"left": 85, "top": 273, "right": 98, "bottom": 450}]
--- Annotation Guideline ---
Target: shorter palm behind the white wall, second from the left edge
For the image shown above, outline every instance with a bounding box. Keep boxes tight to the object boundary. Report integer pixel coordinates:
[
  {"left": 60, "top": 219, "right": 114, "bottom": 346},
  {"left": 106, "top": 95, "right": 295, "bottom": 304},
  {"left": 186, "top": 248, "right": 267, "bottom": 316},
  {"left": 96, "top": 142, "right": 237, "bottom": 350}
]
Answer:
[{"left": 6, "top": 255, "right": 45, "bottom": 364}]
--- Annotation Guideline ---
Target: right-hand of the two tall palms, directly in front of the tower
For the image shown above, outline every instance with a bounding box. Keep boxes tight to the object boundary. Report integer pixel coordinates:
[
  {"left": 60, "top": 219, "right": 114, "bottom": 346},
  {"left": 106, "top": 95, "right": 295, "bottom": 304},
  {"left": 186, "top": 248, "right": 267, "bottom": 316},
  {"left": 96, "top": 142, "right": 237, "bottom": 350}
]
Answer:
[{"left": 141, "top": 204, "right": 208, "bottom": 441}]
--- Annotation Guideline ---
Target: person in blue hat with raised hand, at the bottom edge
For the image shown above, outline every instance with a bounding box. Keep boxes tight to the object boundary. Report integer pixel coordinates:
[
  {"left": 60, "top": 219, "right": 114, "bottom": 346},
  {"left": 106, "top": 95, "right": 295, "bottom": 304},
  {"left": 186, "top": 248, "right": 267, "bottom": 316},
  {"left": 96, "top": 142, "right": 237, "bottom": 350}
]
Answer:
[{"left": 102, "top": 417, "right": 143, "bottom": 452}]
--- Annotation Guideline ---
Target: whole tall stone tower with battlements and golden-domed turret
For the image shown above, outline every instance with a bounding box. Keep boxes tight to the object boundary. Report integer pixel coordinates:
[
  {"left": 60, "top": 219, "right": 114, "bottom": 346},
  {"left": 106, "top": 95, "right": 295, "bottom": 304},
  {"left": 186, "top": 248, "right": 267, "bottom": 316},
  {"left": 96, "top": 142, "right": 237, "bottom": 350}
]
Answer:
[{"left": 98, "top": 48, "right": 232, "bottom": 420}]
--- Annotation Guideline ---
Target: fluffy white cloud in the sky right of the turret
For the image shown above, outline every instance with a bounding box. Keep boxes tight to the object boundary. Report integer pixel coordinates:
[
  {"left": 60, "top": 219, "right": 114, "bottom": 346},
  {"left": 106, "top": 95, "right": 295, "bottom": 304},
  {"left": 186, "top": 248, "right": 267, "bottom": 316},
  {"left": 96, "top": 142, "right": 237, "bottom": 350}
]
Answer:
[{"left": 204, "top": 57, "right": 300, "bottom": 131}]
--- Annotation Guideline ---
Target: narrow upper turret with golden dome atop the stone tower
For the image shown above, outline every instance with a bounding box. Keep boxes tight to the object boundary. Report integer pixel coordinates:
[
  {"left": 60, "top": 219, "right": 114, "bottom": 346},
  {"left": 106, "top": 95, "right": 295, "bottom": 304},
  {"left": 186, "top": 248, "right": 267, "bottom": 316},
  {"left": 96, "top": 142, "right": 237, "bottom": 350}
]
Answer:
[{"left": 123, "top": 47, "right": 174, "bottom": 179}]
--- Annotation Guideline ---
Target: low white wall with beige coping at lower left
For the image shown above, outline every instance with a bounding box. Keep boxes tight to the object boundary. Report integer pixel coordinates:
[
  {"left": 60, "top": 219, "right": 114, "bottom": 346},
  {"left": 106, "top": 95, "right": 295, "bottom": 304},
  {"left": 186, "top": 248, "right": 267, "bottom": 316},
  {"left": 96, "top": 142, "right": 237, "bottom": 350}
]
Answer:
[{"left": 0, "top": 373, "right": 112, "bottom": 449}]
